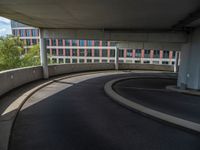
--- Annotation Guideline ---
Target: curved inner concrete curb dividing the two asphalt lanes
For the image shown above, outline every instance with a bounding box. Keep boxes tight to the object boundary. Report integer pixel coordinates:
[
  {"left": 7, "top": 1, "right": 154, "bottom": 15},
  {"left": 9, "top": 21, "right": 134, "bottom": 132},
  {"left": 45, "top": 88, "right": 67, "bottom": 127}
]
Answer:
[{"left": 104, "top": 77, "right": 200, "bottom": 133}]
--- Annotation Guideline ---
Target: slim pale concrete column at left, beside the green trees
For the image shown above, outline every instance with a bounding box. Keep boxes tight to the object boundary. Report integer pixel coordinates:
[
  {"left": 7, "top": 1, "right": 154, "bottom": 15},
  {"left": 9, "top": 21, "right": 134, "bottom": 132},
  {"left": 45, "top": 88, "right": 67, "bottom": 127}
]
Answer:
[{"left": 40, "top": 29, "right": 49, "bottom": 79}]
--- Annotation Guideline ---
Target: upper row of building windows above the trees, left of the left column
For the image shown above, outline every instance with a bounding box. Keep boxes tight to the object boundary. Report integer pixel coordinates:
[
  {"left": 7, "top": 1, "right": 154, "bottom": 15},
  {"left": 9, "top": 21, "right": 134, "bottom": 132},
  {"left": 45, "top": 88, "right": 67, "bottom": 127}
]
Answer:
[{"left": 12, "top": 29, "right": 39, "bottom": 37}]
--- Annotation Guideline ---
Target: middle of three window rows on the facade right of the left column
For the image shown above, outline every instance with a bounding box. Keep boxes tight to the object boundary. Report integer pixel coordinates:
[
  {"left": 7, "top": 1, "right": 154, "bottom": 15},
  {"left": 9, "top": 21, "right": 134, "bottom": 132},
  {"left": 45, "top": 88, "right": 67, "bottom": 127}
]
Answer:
[{"left": 48, "top": 49, "right": 176, "bottom": 58}]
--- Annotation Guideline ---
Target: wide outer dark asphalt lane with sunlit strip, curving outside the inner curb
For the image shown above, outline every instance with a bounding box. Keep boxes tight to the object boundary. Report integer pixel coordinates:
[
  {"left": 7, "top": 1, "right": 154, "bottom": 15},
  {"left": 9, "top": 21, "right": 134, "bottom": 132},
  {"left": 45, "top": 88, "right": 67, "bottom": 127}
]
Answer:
[{"left": 9, "top": 73, "right": 200, "bottom": 150}]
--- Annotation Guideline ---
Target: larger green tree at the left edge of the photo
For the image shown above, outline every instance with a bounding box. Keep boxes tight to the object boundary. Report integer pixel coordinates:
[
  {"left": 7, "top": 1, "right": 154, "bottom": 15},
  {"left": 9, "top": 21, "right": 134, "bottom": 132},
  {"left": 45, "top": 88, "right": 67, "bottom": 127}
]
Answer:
[{"left": 0, "top": 36, "right": 24, "bottom": 70}]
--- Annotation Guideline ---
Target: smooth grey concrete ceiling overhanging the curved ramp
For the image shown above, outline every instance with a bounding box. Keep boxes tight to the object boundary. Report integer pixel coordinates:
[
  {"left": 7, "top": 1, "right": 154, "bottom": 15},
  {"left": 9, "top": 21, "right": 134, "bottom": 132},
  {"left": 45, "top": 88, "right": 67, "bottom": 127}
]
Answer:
[{"left": 0, "top": 0, "right": 200, "bottom": 30}]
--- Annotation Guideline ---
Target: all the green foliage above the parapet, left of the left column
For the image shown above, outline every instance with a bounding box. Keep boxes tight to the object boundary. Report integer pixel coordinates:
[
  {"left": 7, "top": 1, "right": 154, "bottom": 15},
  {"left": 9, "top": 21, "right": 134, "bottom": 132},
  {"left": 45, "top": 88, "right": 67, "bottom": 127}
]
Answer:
[{"left": 0, "top": 36, "right": 40, "bottom": 71}]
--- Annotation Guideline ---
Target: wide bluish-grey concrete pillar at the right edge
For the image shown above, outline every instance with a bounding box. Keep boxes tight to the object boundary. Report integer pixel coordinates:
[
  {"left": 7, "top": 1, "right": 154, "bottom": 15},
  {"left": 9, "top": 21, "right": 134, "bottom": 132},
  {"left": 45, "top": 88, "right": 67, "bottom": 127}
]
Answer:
[{"left": 178, "top": 28, "right": 200, "bottom": 90}]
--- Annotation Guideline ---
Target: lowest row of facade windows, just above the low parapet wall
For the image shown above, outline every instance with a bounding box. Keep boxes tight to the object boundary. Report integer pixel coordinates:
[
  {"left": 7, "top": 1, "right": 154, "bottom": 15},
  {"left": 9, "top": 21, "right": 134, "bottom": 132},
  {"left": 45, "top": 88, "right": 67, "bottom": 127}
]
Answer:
[{"left": 51, "top": 58, "right": 175, "bottom": 65}]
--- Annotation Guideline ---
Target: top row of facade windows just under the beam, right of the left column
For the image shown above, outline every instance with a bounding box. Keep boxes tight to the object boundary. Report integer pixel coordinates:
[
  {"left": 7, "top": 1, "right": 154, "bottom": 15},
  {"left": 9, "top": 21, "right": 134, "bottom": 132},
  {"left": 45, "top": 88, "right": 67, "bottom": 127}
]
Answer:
[{"left": 46, "top": 39, "right": 116, "bottom": 46}]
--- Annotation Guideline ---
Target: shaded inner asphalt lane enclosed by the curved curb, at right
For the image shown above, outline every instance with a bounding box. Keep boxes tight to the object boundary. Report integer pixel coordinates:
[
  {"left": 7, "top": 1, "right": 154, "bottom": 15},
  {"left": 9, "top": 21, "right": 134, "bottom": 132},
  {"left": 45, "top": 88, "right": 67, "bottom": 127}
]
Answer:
[{"left": 114, "top": 78, "right": 200, "bottom": 123}]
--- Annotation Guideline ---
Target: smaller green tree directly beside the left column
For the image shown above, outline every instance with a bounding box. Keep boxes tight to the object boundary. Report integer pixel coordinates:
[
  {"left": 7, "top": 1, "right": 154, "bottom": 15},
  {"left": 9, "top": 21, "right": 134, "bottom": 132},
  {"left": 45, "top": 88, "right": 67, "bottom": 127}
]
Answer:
[{"left": 22, "top": 45, "right": 40, "bottom": 67}]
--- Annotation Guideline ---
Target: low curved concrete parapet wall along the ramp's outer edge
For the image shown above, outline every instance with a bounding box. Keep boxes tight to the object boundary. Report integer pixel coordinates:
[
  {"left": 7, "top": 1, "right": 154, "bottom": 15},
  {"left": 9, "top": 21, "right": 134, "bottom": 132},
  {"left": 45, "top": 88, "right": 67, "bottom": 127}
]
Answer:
[{"left": 0, "top": 63, "right": 173, "bottom": 96}]
